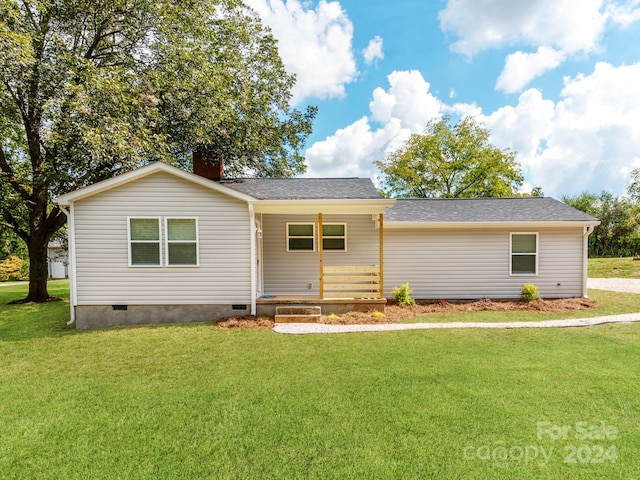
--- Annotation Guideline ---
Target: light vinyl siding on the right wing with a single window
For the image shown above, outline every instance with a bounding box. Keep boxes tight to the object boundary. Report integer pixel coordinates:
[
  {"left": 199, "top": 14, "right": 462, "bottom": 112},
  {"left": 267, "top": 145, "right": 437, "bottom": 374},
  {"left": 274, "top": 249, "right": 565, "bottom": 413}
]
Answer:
[{"left": 384, "top": 228, "right": 583, "bottom": 299}]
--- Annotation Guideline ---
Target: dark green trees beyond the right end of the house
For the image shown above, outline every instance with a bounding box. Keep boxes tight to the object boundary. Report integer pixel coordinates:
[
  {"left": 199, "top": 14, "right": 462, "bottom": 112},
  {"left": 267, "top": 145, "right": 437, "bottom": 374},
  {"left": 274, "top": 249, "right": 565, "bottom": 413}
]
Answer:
[{"left": 562, "top": 192, "right": 640, "bottom": 257}]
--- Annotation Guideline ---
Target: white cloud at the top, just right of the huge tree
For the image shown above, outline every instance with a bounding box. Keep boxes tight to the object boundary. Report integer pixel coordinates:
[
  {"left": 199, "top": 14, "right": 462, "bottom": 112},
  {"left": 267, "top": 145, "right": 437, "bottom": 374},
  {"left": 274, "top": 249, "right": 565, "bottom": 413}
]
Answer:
[{"left": 245, "top": 0, "right": 358, "bottom": 104}]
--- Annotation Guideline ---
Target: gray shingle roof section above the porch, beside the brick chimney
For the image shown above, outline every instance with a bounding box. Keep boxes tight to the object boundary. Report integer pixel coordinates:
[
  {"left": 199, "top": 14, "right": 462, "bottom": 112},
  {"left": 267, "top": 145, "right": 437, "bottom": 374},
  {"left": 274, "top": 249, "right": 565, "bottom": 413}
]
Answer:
[{"left": 220, "top": 178, "right": 380, "bottom": 200}]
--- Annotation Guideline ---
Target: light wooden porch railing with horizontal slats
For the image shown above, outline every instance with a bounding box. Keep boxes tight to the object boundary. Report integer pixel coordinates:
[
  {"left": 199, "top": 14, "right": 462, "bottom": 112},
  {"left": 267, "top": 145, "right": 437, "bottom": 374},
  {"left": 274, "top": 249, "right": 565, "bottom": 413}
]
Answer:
[{"left": 320, "top": 265, "right": 384, "bottom": 299}]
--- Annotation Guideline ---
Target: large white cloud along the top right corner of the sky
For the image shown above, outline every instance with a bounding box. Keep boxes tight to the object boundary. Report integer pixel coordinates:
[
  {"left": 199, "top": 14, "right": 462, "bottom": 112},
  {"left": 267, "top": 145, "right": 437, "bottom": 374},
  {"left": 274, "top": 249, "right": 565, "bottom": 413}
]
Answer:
[{"left": 439, "top": 0, "right": 640, "bottom": 93}]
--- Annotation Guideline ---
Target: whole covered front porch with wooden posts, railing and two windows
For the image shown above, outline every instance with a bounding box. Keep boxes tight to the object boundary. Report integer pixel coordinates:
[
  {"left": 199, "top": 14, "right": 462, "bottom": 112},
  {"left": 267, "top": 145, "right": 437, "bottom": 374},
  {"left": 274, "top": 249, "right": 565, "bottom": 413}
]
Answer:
[{"left": 255, "top": 205, "right": 387, "bottom": 321}]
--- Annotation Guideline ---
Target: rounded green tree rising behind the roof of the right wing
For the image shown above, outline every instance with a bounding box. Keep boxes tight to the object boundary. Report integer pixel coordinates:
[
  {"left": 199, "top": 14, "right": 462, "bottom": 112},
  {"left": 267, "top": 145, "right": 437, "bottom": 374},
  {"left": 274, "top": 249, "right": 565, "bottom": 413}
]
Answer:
[{"left": 377, "top": 116, "right": 523, "bottom": 198}]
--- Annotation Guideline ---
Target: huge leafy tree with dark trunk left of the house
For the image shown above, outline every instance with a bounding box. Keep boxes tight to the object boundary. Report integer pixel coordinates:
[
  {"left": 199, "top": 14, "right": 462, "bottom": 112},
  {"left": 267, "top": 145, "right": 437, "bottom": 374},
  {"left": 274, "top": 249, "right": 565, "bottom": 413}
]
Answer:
[{"left": 0, "top": 0, "right": 315, "bottom": 301}]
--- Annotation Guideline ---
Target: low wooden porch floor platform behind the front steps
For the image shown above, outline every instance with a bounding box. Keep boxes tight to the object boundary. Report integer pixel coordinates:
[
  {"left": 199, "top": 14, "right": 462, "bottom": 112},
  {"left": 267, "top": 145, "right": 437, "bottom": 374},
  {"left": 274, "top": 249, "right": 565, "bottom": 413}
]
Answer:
[{"left": 256, "top": 295, "right": 387, "bottom": 316}]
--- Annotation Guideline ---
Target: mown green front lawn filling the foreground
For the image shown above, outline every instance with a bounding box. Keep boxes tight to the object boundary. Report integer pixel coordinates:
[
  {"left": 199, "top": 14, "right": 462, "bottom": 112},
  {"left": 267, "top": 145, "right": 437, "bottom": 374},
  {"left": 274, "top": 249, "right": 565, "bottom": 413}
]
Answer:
[{"left": 0, "top": 284, "right": 640, "bottom": 479}]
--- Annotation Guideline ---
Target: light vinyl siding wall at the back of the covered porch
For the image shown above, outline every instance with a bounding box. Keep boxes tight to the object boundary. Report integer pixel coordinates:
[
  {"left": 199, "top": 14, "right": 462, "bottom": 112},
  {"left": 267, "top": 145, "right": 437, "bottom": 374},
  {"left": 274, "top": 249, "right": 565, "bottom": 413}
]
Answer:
[{"left": 262, "top": 214, "right": 380, "bottom": 295}]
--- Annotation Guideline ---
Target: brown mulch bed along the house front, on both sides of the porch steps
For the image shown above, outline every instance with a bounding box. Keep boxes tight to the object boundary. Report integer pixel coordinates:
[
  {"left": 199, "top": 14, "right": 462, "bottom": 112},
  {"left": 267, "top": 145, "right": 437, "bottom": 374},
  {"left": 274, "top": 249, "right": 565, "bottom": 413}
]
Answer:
[{"left": 216, "top": 298, "right": 599, "bottom": 329}]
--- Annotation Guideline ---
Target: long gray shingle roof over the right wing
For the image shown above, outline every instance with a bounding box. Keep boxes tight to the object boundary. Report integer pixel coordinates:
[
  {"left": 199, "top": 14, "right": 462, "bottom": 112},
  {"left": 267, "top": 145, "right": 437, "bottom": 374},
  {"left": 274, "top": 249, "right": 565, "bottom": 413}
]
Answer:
[{"left": 385, "top": 197, "right": 597, "bottom": 223}]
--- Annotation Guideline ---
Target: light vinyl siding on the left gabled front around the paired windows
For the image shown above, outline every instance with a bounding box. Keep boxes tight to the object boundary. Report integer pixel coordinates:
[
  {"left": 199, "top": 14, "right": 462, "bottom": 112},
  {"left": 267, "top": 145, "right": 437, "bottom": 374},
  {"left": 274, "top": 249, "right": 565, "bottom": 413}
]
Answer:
[{"left": 74, "top": 172, "right": 251, "bottom": 305}]
